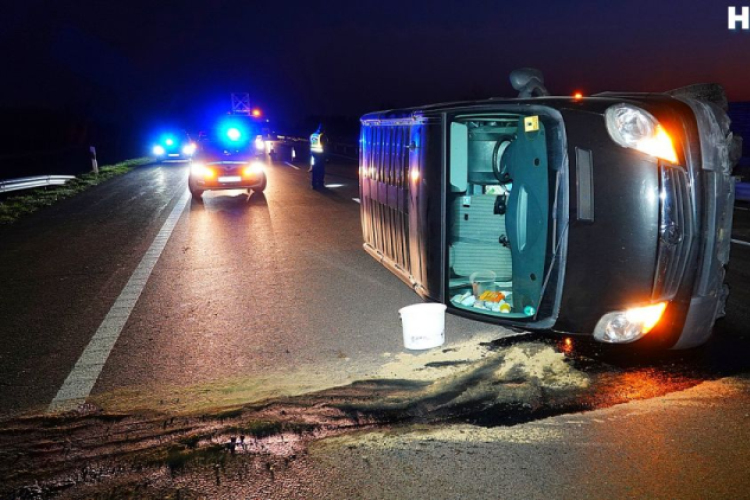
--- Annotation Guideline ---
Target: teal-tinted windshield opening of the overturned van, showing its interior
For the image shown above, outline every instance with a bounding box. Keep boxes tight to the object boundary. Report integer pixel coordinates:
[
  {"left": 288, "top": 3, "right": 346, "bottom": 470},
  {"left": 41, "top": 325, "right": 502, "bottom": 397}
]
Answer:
[{"left": 446, "top": 113, "right": 562, "bottom": 321}]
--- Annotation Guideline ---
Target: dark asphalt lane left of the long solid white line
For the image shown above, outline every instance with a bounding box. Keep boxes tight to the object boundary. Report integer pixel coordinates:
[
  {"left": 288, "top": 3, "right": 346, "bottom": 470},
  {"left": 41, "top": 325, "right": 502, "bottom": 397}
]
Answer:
[{"left": 0, "top": 166, "right": 184, "bottom": 414}]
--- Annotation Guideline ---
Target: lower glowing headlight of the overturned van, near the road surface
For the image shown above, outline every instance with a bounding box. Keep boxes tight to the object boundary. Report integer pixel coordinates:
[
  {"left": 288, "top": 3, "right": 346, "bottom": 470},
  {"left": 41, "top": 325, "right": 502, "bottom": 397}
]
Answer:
[{"left": 594, "top": 302, "right": 667, "bottom": 344}]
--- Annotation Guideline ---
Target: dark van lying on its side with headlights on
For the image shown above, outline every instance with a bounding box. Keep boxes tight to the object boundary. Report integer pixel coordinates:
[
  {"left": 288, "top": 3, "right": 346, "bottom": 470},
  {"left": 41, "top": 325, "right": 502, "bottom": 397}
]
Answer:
[{"left": 359, "top": 69, "right": 741, "bottom": 349}]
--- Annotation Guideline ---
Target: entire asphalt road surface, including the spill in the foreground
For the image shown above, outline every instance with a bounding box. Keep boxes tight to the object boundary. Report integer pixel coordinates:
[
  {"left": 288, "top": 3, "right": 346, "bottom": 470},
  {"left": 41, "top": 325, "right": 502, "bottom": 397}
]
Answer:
[{"left": 0, "top": 154, "right": 750, "bottom": 498}]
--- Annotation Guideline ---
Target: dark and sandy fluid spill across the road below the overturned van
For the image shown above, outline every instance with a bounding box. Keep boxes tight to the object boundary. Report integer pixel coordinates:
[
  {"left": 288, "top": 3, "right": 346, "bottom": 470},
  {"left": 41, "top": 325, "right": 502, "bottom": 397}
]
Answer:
[{"left": 0, "top": 335, "right": 750, "bottom": 498}]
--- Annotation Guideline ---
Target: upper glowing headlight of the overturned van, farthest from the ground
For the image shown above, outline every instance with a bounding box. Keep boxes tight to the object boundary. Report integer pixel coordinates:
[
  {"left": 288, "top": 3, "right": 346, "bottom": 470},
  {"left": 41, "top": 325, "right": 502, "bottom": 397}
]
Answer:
[{"left": 606, "top": 104, "right": 677, "bottom": 163}]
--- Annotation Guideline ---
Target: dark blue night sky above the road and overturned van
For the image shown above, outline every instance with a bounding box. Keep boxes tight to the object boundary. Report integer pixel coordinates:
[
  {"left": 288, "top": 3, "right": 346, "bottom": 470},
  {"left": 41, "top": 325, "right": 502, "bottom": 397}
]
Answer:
[{"left": 0, "top": 0, "right": 750, "bottom": 129}]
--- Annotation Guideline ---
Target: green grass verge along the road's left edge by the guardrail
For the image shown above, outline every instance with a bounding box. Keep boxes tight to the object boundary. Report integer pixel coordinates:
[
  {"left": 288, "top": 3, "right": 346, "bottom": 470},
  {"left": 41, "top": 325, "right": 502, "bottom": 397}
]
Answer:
[{"left": 0, "top": 158, "right": 153, "bottom": 225}]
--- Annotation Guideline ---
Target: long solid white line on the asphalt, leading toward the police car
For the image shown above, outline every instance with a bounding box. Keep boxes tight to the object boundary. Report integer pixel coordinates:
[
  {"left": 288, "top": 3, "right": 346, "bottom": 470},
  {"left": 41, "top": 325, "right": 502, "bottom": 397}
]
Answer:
[{"left": 47, "top": 192, "right": 190, "bottom": 412}]
